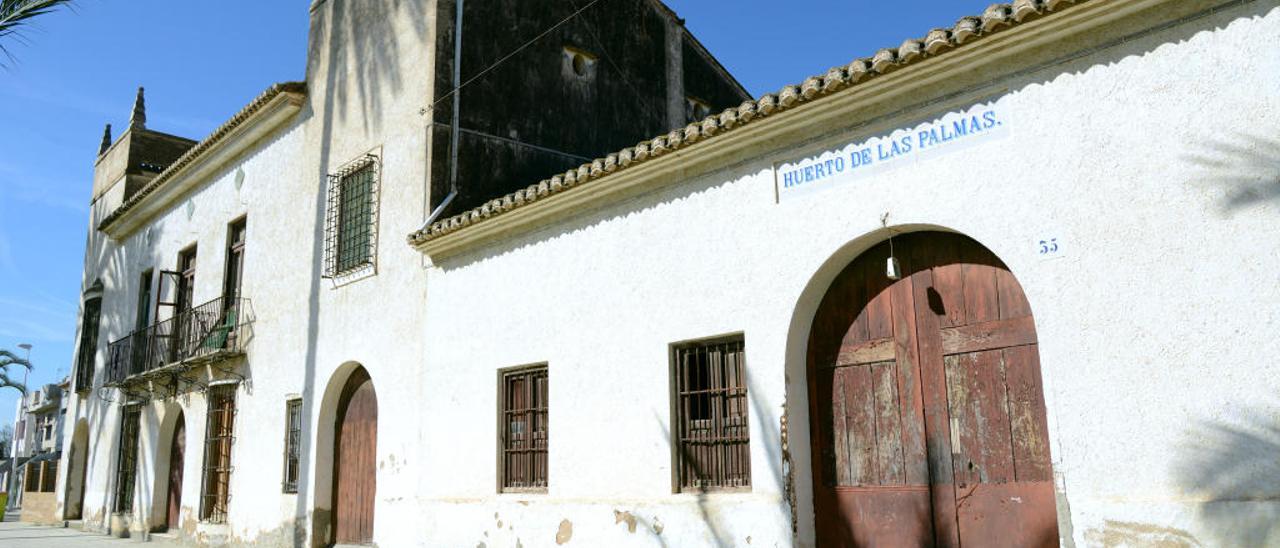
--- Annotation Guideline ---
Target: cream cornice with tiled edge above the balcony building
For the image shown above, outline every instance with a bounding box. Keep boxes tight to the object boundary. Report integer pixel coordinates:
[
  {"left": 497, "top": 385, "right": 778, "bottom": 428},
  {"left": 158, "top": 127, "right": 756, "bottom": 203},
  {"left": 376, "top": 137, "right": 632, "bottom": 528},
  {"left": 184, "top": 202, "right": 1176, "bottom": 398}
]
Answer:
[{"left": 97, "top": 82, "right": 306, "bottom": 239}]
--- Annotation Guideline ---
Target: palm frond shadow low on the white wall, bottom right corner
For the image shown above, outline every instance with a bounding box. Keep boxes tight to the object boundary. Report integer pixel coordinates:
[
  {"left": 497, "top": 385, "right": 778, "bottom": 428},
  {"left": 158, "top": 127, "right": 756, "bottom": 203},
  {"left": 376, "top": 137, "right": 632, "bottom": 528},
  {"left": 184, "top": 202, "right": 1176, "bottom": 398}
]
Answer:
[{"left": 1176, "top": 415, "right": 1280, "bottom": 547}]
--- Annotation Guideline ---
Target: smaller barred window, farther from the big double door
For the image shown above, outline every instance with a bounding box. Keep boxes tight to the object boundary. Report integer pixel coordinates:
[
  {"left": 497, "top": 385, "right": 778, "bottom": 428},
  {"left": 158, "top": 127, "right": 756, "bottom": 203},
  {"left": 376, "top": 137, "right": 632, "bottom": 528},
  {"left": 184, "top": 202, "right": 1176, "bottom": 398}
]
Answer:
[{"left": 499, "top": 365, "right": 548, "bottom": 493}]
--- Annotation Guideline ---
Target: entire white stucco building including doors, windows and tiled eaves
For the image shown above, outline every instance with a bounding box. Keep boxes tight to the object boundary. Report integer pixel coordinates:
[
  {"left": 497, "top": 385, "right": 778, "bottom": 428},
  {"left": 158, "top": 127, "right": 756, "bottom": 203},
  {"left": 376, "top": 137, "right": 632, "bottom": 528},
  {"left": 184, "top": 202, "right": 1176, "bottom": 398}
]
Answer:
[{"left": 59, "top": 0, "right": 1280, "bottom": 547}]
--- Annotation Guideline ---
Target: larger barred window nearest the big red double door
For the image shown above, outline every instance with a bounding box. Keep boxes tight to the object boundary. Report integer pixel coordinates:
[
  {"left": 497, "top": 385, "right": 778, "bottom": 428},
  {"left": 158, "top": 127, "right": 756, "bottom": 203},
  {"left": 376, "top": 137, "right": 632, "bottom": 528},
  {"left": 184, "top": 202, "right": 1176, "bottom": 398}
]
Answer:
[{"left": 673, "top": 337, "right": 751, "bottom": 492}]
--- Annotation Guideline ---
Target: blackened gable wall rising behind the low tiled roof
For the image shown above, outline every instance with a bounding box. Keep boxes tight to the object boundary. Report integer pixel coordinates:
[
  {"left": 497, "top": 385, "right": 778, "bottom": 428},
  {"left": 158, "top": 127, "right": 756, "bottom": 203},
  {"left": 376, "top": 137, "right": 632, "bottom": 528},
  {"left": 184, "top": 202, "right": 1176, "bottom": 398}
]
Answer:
[{"left": 431, "top": 0, "right": 745, "bottom": 214}]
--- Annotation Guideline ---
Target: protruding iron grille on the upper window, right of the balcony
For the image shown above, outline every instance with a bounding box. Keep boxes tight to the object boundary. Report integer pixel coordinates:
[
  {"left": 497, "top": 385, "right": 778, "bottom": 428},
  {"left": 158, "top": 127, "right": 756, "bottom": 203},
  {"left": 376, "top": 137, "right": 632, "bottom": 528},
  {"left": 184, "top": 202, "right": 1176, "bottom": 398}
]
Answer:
[{"left": 324, "top": 154, "right": 380, "bottom": 278}]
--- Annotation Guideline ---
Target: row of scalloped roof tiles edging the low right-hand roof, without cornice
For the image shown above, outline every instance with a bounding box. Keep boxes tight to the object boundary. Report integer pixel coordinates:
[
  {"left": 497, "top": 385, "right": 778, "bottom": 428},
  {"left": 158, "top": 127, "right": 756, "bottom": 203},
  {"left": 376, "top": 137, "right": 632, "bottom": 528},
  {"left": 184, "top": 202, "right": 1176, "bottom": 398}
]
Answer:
[{"left": 407, "top": 0, "right": 1089, "bottom": 245}]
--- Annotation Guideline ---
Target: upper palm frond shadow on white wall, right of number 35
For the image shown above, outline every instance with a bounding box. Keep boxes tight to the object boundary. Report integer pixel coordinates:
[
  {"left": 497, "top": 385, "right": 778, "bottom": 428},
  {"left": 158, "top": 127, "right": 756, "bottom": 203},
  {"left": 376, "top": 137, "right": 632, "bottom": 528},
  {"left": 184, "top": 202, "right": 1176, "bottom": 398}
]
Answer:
[{"left": 1185, "top": 134, "right": 1280, "bottom": 216}]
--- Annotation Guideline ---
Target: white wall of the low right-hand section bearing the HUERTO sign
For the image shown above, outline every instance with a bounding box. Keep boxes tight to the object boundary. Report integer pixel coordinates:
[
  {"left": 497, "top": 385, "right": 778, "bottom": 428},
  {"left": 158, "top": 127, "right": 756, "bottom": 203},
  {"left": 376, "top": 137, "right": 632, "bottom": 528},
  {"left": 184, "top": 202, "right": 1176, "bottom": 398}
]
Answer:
[{"left": 415, "top": 3, "right": 1280, "bottom": 545}]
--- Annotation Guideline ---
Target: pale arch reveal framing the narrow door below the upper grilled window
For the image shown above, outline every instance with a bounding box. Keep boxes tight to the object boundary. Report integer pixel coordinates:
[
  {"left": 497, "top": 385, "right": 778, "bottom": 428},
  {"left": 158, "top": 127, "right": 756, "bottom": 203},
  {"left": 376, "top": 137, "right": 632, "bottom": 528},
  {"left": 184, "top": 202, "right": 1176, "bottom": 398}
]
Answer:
[{"left": 311, "top": 361, "right": 372, "bottom": 544}]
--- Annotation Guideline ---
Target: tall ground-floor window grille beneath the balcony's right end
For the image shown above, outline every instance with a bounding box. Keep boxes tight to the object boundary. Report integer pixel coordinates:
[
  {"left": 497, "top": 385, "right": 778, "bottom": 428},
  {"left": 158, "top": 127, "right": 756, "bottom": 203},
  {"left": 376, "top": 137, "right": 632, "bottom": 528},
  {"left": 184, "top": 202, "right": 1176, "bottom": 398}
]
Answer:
[{"left": 200, "top": 384, "right": 236, "bottom": 524}]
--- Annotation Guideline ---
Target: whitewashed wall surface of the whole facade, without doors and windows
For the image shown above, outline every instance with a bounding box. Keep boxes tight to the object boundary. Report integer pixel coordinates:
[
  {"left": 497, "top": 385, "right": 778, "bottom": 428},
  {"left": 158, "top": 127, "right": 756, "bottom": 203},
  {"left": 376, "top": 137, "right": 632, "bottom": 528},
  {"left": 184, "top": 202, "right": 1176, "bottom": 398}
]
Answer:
[{"left": 60, "top": 1, "right": 1280, "bottom": 547}]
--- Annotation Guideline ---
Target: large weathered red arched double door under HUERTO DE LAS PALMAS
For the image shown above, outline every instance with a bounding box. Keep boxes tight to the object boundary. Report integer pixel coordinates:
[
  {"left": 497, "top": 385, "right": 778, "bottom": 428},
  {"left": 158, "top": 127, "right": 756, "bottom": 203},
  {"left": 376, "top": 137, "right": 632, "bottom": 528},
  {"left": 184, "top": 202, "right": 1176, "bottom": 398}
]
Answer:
[{"left": 808, "top": 232, "right": 1057, "bottom": 547}]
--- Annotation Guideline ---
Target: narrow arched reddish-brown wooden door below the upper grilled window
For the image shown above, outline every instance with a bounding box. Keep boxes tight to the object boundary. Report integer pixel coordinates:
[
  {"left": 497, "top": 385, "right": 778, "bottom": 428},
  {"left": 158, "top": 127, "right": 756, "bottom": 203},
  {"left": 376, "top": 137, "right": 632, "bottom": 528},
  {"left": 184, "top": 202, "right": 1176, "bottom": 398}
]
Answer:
[{"left": 333, "top": 367, "right": 378, "bottom": 544}]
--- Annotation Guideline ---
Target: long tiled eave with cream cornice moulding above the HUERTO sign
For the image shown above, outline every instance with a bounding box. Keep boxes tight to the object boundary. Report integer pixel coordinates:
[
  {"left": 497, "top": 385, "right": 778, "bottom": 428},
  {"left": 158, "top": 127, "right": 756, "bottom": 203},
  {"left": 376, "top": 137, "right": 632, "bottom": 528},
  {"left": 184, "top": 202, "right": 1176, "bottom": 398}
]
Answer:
[{"left": 407, "top": 0, "right": 1187, "bottom": 260}]
